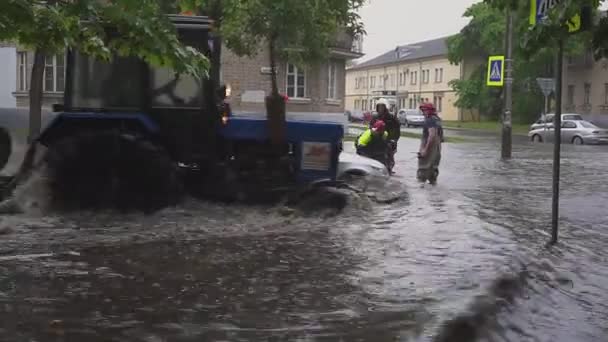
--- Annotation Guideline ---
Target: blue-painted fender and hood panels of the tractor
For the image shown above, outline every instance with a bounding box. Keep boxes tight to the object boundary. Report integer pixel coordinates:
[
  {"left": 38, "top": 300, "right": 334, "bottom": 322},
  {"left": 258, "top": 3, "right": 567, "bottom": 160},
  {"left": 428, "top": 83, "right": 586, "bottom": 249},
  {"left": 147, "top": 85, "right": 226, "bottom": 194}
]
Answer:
[{"left": 38, "top": 112, "right": 344, "bottom": 185}]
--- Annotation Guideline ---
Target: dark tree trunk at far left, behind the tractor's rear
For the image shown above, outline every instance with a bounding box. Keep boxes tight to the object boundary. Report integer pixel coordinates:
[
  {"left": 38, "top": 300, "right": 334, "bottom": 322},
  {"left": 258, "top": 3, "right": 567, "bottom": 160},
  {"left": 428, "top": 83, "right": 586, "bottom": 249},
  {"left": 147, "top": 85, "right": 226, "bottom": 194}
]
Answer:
[{"left": 28, "top": 49, "right": 44, "bottom": 144}]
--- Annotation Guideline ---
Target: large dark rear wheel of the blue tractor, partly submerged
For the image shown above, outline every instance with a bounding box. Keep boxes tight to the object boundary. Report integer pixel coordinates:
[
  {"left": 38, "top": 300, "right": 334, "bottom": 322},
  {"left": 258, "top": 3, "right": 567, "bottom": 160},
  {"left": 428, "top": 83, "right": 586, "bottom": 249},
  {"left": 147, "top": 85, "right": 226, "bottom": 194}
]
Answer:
[{"left": 46, "top": 131, "right": 183, "bottom": 212}]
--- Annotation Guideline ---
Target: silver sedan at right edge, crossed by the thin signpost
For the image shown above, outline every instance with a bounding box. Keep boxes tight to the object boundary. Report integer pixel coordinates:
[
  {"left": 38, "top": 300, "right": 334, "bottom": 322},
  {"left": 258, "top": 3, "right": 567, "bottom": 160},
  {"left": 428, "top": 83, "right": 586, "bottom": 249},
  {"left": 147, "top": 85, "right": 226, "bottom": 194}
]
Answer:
[{"left": 528, "top": 120, "right": 608, "bottom": 145}]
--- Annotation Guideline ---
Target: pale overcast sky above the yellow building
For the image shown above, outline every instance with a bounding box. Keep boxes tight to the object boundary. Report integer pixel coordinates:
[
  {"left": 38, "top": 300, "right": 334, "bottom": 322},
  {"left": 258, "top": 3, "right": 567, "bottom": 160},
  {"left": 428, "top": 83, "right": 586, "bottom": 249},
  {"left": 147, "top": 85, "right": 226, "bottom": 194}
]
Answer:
[{"left": 359, "top": 0, "right": 608, "bottom": 62}]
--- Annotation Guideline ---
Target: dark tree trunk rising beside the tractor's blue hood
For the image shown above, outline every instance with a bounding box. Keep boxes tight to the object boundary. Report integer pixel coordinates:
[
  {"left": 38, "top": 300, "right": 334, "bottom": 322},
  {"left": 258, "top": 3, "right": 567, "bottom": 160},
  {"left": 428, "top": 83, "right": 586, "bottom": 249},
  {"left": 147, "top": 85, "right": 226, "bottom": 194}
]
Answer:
[{"left": 266, "top": 39, "right": 286, "bottom": 148}]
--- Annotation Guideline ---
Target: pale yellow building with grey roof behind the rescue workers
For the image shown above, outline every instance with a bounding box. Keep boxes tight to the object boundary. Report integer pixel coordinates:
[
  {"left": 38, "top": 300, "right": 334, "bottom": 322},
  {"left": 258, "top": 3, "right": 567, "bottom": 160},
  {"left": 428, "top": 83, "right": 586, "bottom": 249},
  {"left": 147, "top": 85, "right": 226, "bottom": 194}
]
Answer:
[{"left": 345, "top": 37, "right": 472, "bottom": 120}]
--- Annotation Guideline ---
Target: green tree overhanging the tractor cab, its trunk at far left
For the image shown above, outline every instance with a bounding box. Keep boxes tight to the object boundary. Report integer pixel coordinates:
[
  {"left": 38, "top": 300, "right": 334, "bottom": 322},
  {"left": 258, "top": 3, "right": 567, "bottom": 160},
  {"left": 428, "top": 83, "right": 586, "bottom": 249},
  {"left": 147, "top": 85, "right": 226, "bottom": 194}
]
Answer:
[{"left": 0, "top": 0, "right": 209, "bottom": 139}]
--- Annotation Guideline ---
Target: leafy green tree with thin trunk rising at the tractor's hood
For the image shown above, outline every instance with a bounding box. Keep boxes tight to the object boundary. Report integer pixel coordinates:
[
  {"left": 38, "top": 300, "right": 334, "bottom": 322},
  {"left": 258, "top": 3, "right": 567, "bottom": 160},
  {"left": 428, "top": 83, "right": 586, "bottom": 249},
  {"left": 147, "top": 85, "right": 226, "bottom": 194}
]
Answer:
[{"left": 214, "top": 0, "right": 365, "bottom": 143}]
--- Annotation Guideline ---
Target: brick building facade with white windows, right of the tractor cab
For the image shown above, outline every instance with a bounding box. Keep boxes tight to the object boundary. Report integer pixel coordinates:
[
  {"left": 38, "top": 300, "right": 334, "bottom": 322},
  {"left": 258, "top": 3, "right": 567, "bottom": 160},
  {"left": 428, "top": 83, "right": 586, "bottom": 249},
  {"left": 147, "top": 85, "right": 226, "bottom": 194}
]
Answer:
[{"left": 221, "top": 36, "right": 362, "bottom": 113}]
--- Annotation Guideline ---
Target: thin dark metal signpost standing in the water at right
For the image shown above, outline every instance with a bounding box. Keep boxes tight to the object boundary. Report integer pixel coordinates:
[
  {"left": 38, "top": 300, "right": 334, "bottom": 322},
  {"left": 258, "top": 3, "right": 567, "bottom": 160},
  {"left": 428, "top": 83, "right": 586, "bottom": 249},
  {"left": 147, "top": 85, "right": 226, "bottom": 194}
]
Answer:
[{"left": 551, "top": 37, "right": 564, "bottom": 244}]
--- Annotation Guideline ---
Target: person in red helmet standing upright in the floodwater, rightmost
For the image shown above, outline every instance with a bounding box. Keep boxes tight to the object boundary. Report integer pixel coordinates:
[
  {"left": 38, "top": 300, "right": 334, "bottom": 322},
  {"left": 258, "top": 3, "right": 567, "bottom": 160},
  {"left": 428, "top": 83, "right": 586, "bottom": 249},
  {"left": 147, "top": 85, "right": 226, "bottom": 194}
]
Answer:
[{"left": 416, "top": 103, "right": 443, "bottom": 184}]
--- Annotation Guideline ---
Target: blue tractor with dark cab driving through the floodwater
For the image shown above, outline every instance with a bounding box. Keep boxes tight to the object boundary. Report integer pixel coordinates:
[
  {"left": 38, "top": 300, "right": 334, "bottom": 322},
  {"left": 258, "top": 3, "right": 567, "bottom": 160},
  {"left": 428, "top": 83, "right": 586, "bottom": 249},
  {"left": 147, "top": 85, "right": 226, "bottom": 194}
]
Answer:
[{"left": 28, "top": 15, "right": 344, "bottom": 210}]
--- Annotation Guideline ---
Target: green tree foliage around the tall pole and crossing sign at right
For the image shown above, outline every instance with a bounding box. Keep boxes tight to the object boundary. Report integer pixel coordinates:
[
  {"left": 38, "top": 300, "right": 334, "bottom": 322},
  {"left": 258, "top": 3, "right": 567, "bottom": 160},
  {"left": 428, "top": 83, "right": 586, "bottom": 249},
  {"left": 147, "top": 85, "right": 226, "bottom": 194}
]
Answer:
[{"left": 448, "top": 0, "right": 592, "bottom": 122}]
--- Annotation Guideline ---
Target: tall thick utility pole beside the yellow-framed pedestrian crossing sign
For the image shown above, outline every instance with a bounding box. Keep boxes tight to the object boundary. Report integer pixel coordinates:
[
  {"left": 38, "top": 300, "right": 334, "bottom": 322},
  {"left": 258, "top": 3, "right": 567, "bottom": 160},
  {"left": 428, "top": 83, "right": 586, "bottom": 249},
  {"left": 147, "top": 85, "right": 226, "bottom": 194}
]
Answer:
[{"left": 501, "top": 7, "right": 513, "bottom": 159}]
